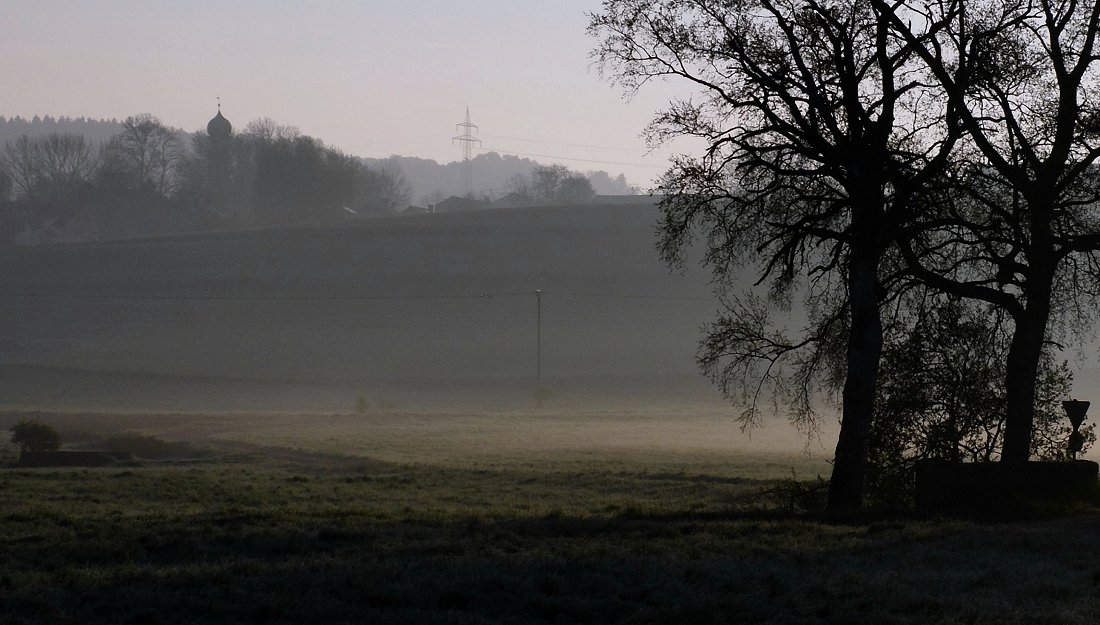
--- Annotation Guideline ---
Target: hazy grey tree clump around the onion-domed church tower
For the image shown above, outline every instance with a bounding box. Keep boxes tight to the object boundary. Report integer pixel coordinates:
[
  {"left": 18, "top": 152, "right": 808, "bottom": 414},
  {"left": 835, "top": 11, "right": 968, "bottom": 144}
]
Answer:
[{"left": 0, "top": 113, "right": 409, "bottom": 244}]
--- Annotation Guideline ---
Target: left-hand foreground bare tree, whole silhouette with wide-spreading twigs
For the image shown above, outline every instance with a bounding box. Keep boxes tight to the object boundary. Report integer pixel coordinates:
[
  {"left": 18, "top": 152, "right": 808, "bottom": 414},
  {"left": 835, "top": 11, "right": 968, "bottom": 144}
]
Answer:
[{"left": 590, "top": 0, "right": 959, "bottom": 512}]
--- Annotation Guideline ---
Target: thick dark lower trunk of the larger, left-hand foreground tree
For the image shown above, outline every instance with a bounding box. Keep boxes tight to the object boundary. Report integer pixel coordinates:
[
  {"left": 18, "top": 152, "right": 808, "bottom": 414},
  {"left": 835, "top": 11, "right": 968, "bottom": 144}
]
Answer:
[{"left": 827, "top": 254, "right": 882, "bottom": 514}]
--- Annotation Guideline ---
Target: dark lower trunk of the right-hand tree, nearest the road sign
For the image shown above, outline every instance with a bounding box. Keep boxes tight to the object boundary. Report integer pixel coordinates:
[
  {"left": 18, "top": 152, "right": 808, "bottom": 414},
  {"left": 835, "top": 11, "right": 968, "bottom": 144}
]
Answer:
[{"left": 1001, "top": 281, "right": 1051, "bottom": 463}]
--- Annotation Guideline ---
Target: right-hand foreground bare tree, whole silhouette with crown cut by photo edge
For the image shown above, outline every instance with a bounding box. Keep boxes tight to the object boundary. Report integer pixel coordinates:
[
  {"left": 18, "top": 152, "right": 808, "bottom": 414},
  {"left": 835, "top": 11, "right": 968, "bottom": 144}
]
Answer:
[{"left": 873, "top": 0, "right": 1100, "bottom": 462}]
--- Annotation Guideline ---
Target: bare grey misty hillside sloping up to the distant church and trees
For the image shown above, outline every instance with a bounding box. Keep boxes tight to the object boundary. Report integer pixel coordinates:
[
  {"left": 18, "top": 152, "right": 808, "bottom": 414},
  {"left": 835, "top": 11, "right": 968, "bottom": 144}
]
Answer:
[{"left": 0, "top": 204, "right": 716, "bottom": 408}]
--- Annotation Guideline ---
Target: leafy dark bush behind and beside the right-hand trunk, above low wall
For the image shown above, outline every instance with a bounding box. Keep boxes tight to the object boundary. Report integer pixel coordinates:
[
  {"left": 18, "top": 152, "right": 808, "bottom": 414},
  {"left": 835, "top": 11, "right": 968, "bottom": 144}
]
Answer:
[{"left": 868, "top": 295, "right": 1096, "bottom": 505}]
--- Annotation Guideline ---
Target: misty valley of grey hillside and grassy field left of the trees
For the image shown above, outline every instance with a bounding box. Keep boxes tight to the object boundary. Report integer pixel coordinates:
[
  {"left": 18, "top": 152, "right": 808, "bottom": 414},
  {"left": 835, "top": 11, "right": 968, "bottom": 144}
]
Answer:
[{"left": 0, "top": 200, "right": 1100, "bottom": 623}]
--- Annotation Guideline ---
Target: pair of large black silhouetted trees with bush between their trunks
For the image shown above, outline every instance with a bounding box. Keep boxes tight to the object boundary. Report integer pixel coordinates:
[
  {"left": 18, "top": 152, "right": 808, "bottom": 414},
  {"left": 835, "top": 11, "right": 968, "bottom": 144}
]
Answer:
[{"left": 590, "top": 0, "right": 1100, "bottom": 512}]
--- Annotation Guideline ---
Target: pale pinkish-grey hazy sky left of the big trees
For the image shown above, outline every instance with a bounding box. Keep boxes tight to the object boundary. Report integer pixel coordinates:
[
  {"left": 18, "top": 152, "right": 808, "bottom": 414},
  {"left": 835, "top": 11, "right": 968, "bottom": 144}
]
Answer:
[{"left": 0, "top": 0, "right": 683, "bottom": 186}]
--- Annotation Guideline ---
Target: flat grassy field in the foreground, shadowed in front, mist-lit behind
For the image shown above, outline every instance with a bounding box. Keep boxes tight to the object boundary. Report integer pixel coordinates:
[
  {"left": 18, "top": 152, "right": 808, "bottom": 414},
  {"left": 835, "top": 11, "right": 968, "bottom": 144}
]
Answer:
[{"left": 0, "top": 409, "right": 1100, "bottom": 624}]
